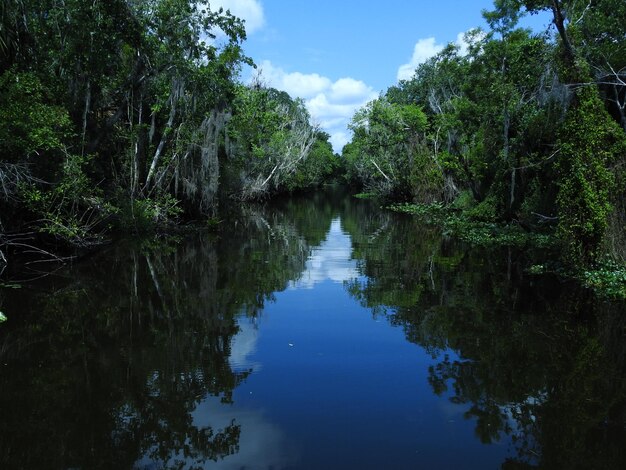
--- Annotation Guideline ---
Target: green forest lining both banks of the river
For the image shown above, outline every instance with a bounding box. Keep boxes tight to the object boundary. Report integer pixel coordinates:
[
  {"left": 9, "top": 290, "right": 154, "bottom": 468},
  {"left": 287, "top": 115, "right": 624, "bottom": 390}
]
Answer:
[{"left": 0, "top": 0, "right": 626, "bottom": 296}]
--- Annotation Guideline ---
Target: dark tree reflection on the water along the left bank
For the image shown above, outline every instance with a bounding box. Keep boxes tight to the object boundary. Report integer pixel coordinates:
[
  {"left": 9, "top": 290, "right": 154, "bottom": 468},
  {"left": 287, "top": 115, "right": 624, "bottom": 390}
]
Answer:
[{"left": 0, "top": 200, "right": 332, "bottom": 468}]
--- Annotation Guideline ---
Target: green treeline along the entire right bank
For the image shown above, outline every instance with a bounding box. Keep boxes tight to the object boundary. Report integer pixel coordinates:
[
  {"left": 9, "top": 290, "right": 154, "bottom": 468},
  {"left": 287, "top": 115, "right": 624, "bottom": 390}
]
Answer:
[{"left": 343, "top": 0, "right": 626, "bottom": 266}]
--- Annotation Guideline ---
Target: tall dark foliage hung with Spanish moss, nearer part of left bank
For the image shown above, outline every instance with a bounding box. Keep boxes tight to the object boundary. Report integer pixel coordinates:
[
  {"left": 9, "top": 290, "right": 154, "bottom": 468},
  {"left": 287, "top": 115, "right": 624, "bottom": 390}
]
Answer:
[{"left": 0, "top": 0, "right": 251, "bottom": 253}]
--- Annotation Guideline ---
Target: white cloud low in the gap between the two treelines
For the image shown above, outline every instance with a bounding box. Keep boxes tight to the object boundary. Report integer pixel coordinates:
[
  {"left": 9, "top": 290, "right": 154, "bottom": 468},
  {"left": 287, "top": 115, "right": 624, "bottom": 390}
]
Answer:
[{"left": 254, "top": 60, "right": 378, "bottom": 152}]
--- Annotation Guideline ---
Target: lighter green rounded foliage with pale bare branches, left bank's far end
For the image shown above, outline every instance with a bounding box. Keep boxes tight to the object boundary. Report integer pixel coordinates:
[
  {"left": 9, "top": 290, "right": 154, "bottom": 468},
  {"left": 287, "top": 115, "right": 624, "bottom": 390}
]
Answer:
[{"left": 228, "top": 79, "right": 338, "bottom": 200}]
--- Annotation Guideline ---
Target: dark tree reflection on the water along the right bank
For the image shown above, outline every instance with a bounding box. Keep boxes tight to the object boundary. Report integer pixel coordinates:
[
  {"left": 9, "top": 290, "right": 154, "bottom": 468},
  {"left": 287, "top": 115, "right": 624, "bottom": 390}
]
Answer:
[{"left": 346, "top": 213, "right": 626, "bottom": 468}]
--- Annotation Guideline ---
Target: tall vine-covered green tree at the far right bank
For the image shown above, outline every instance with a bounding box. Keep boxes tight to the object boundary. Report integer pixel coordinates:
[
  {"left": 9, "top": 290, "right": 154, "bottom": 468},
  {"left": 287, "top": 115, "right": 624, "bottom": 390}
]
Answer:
[{"left": 488, "top": 0, "right": 626, "bottom": 260}]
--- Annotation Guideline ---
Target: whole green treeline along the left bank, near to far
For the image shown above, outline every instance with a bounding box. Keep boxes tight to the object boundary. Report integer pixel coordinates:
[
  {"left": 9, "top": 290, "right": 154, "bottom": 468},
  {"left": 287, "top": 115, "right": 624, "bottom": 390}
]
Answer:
[{"left": 0, "top": 0, "right": 338, "bottom": 269}]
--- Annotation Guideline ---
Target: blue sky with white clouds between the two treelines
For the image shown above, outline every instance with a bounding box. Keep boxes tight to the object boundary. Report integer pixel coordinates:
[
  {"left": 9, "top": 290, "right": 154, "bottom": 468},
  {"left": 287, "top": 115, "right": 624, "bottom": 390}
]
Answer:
[{"left": 210, "top": 0, "right": 545, "bottom": 152}]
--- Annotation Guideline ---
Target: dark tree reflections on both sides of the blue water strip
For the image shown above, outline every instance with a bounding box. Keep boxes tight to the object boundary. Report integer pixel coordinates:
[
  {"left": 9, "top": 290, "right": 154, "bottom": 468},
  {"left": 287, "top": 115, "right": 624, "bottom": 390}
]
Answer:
[{"left": 0, "top": 189, "right": 626, "bottom": 468}]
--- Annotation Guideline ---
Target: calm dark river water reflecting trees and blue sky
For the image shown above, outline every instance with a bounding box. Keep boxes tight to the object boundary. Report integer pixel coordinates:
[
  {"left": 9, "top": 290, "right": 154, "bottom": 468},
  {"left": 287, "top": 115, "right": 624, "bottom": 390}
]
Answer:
[{"left": 0, "top": 189, "right": 626, "bottom": 469}]
